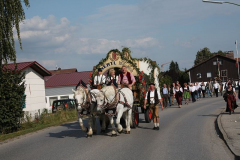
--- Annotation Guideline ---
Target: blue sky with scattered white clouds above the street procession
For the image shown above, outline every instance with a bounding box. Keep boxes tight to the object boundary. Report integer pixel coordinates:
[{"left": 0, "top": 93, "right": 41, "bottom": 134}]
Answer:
[{"left": 16, "top": 0, "right": 240, "bottom": 71}]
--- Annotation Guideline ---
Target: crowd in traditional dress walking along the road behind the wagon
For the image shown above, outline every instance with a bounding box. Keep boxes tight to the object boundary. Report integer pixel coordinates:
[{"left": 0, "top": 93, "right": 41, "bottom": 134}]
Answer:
[{"left": 161, "top": 79, "right": 240, "bottom": 114}]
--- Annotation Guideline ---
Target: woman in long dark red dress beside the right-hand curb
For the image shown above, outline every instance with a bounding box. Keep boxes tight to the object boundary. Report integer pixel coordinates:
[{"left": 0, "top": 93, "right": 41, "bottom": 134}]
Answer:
[{"left": 226, "top": 83, "right": 237, "bottom": 115}]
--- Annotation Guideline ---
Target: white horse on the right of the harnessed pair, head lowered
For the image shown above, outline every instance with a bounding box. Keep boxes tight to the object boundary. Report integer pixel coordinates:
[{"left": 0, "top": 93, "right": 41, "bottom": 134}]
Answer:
[{"left": 96, "top": 86, "right": 133, "bottom": 136}]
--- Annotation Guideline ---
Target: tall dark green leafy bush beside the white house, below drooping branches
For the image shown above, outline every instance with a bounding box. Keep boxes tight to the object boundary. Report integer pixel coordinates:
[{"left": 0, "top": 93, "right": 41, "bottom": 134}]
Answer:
[{"left": 0, "top": 68, "right": 26, "bottom": 134}]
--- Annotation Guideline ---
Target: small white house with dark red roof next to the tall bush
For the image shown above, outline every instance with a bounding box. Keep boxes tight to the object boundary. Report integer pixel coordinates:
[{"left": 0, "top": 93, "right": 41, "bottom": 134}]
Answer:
[{"left": 7, "top": 61, "right": 51, "bottom": 117}]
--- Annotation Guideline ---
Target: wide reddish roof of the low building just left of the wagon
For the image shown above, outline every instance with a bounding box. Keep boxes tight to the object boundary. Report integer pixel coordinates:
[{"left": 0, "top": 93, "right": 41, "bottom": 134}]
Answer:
[{"left": 44, "top": 71, "right": 92, "bottom": 88}]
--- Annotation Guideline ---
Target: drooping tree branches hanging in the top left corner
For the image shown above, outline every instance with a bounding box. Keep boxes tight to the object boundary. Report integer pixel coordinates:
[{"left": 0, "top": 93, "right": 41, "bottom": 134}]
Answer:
[{"left": 0, "top": 0, "right": 30, "bottom": 67}]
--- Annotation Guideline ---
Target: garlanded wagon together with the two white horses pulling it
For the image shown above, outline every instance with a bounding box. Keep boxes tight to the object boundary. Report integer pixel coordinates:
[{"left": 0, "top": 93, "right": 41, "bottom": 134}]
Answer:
[{"left": 73, "top": 49, "right": 159, "bottom": 136}]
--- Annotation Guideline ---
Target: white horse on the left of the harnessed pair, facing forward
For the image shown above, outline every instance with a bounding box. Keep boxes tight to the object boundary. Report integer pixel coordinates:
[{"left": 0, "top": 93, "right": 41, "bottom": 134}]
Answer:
[{"left": 72, "top": 86, "right": 107, "bottom": 137}]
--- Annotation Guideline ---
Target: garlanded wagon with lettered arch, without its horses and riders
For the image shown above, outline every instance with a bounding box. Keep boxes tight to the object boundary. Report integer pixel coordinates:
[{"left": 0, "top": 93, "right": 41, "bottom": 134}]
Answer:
[{"left": 89, "top": 48, "right": 160, "bottom": 125}]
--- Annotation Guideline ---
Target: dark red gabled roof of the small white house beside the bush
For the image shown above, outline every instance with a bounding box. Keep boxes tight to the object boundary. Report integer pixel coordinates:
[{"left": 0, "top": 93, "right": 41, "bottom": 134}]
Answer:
[{"left": 4, "top": 61, "right": 51, "bottom": 76}]
